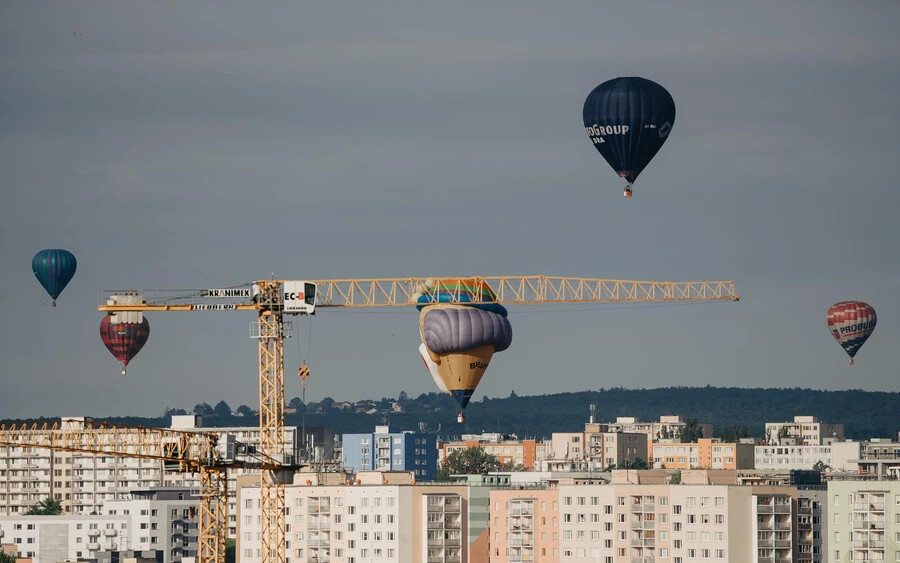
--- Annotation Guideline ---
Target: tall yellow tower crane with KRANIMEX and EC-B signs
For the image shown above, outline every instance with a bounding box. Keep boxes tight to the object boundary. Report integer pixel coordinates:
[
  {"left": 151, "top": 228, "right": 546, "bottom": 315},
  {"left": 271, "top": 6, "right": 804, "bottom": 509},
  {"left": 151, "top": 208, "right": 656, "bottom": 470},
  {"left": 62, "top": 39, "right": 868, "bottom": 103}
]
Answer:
[{"left": 91, "top": 276, "right": 740, "bottom": 563}]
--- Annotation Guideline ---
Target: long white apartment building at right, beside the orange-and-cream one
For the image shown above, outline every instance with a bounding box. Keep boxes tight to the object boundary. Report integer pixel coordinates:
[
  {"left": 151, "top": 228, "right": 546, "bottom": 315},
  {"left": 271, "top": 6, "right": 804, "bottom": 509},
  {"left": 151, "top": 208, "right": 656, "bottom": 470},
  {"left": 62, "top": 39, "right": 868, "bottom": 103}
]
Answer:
[{"left": 754, "top": 442, "right": 860, "bottom": 472}]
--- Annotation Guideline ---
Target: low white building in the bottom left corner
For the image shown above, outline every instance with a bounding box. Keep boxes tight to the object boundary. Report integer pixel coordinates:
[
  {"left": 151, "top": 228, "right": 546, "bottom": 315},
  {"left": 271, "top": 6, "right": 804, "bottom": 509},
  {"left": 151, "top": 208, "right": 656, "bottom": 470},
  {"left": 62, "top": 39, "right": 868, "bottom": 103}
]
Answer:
[{"left": 0, "top": 515, "right": 129, "bottom": 563}]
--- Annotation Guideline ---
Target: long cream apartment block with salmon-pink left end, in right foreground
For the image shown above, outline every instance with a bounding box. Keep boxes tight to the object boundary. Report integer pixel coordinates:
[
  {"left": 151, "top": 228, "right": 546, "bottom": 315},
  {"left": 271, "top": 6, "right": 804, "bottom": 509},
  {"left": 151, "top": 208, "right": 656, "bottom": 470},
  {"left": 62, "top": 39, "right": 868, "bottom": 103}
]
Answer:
[{"left": 489, "top": 471, "right": 811, "bottom": 563}]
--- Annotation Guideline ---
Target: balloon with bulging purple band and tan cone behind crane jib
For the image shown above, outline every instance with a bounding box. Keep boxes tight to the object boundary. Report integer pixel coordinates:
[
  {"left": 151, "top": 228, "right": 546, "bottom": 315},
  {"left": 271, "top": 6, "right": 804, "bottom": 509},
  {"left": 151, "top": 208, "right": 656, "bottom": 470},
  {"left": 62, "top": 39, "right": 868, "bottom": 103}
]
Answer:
[{"left": 419, "top": 280, "right": 512, "bottom": 423}]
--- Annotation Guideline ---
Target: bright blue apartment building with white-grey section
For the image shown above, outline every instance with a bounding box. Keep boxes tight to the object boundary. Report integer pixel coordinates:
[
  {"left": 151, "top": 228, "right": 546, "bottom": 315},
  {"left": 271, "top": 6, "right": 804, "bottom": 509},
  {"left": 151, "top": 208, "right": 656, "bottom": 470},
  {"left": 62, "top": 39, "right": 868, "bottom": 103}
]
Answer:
[{"left": 341, "top": 425, "right": 437, "bottom": 481}]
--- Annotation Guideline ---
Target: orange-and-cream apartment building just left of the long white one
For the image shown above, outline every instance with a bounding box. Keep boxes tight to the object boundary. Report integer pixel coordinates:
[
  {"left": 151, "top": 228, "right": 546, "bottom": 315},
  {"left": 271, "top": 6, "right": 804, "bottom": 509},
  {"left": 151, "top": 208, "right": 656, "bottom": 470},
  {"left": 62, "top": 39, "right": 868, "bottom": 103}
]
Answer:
[{"left": 650, "top": 438, "right": 754, "bottom": 469}]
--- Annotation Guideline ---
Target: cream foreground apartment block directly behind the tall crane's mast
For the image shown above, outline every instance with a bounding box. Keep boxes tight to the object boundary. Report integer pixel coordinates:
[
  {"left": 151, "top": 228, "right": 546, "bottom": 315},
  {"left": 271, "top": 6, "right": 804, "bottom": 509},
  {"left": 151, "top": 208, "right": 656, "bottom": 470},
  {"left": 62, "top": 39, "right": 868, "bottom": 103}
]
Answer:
[{"left": 236, "top": 471, "right": 490, "bottom": 563}]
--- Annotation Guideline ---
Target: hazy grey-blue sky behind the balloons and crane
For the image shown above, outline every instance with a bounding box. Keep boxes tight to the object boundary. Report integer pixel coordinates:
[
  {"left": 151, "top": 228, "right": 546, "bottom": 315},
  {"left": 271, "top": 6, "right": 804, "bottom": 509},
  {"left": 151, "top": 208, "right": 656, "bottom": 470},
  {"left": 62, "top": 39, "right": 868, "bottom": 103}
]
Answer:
[{"left": 0, "top": 0, "right": 900, "bottom": 418}]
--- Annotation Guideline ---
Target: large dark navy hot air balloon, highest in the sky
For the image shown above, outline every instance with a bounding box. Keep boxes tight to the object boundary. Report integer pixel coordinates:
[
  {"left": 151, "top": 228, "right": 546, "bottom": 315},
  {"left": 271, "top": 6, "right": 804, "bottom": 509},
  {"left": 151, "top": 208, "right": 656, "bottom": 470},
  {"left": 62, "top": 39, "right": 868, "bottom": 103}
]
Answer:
[{"left": 583, "top": 76, "right": 675, "bottom": 197}]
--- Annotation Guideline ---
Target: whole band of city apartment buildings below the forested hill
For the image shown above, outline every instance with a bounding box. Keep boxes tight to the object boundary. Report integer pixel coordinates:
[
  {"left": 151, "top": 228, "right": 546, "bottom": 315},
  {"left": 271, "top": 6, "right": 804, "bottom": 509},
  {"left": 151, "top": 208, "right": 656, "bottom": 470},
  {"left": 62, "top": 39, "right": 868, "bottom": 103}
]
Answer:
[{"left": 0, "top": 415, "right": 900, "bottom": 563}]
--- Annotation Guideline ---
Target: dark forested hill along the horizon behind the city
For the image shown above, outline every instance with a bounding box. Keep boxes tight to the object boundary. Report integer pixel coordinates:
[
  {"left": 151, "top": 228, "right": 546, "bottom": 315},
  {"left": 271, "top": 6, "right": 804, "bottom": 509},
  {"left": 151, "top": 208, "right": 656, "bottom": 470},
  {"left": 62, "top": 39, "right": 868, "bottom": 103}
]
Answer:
[{"left": 4, "top": 386, "right": 900, "bottom": 440}]
